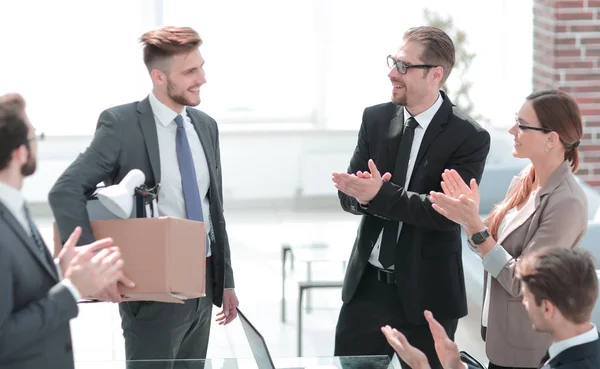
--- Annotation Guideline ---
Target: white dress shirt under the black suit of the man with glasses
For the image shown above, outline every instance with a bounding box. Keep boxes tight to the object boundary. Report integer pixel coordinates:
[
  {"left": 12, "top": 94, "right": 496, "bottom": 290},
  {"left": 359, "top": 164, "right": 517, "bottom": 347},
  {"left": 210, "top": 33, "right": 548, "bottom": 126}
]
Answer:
[{"left": 369, "top": 94, "right": 444, "bottom": 269}]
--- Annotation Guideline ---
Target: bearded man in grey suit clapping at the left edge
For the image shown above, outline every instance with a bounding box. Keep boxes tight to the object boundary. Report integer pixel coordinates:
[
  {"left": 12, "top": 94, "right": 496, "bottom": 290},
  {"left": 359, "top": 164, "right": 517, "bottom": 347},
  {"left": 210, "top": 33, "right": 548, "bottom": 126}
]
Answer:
[{"left": 0, "top": 94, "right": 123, "bottom": 369}]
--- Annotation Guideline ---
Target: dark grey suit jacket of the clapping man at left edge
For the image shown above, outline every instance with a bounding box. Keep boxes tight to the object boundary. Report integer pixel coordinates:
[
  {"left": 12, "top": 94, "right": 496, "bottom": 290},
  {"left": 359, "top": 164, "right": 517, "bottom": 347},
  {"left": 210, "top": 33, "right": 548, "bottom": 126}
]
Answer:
[{"left": 0, "top": 202, "right": 78, "bottom": 369}]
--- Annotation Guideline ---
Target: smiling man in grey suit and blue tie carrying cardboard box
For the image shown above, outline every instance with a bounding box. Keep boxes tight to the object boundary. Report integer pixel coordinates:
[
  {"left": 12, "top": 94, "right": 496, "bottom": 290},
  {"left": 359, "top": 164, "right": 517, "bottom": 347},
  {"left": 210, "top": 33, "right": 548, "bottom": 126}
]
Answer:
[{"left": 49, "top": 27, "right": 238, "bottom": 366}]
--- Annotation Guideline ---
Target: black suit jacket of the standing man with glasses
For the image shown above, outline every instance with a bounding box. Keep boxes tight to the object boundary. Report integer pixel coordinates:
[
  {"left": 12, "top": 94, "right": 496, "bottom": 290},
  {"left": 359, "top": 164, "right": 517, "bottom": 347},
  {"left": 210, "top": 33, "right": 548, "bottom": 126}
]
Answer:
[{"left": 339, "top": 92, "right": 490, "bottom": 324}]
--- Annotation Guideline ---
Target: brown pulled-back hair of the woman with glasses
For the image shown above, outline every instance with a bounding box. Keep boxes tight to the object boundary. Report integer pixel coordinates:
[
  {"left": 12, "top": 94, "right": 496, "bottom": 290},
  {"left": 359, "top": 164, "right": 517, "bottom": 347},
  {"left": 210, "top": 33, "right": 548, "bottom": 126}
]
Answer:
[{"left": 527, "top": 90, "right": 583, "bottom": 172}]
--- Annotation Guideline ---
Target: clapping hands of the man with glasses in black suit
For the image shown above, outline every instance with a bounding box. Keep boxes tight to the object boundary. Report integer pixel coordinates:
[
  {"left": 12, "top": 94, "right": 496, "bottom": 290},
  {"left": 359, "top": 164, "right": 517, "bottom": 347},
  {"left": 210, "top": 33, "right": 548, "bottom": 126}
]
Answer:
[{"left": 331, "top": 159, "right": 392, "bottom": 205}]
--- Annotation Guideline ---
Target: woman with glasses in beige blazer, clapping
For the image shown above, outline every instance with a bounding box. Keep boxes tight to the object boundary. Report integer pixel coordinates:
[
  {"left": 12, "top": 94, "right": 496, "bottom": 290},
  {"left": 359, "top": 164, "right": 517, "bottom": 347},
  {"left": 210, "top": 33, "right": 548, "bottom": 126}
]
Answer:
[{"left": 430, "top": 90, "right": 587, "bottom": 369}]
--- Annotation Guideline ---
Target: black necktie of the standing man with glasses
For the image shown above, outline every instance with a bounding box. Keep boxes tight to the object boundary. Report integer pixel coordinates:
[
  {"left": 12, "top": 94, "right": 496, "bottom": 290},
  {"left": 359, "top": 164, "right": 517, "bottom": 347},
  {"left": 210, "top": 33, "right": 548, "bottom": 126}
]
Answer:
[{"left": 379, "top": 117, "right": 419, "bottom": 269}]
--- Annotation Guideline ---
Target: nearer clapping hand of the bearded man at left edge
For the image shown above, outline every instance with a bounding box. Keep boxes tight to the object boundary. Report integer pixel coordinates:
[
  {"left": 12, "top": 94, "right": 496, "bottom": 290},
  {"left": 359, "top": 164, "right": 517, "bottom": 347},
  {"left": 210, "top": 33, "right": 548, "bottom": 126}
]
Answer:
[{"left": 64, "top": 239, "right": 123, "bottom": 296}]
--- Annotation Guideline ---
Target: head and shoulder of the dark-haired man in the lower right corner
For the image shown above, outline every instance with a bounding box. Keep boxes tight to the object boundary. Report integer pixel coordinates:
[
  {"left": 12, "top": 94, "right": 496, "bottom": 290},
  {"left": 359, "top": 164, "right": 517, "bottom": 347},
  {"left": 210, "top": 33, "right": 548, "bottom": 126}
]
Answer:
[{"left": 517, "top": 247, "right": 600, "bottom": 369}]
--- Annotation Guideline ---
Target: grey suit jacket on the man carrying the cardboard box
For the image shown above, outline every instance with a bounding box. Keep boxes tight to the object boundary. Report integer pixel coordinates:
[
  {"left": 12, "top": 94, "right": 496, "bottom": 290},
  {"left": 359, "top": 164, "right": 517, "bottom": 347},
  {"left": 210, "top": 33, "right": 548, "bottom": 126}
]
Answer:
[{"left": 49, "top": 98, "right": 234, "bottom": 306}]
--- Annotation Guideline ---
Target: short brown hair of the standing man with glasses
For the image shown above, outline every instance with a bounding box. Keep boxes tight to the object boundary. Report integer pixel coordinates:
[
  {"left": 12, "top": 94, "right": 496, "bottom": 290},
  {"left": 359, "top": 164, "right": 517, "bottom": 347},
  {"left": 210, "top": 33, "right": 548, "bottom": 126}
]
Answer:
[{"left": 404, "top": 26, "right": 456, "bottom": 85}]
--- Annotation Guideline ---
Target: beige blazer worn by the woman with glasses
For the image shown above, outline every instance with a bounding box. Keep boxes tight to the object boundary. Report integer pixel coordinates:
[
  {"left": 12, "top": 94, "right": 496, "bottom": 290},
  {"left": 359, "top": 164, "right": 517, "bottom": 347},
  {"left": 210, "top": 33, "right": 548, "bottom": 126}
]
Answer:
[{"left": 483, "top": 161, "right": 588, "bottom": 368}]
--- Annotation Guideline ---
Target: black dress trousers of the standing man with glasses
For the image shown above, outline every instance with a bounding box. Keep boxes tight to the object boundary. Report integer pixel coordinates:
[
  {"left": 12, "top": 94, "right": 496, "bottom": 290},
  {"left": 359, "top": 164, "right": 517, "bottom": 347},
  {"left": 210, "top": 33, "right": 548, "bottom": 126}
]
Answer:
[{"left": 334, "top": 263, "right": 458, "bottom": 369}]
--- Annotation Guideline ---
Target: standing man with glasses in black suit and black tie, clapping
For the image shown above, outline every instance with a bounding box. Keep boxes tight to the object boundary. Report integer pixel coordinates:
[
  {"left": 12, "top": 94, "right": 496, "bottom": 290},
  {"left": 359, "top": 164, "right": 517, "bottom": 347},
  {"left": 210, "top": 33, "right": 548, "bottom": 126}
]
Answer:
[{"left": 333, "top": 27, "right": 490, "bottom": 368}]
